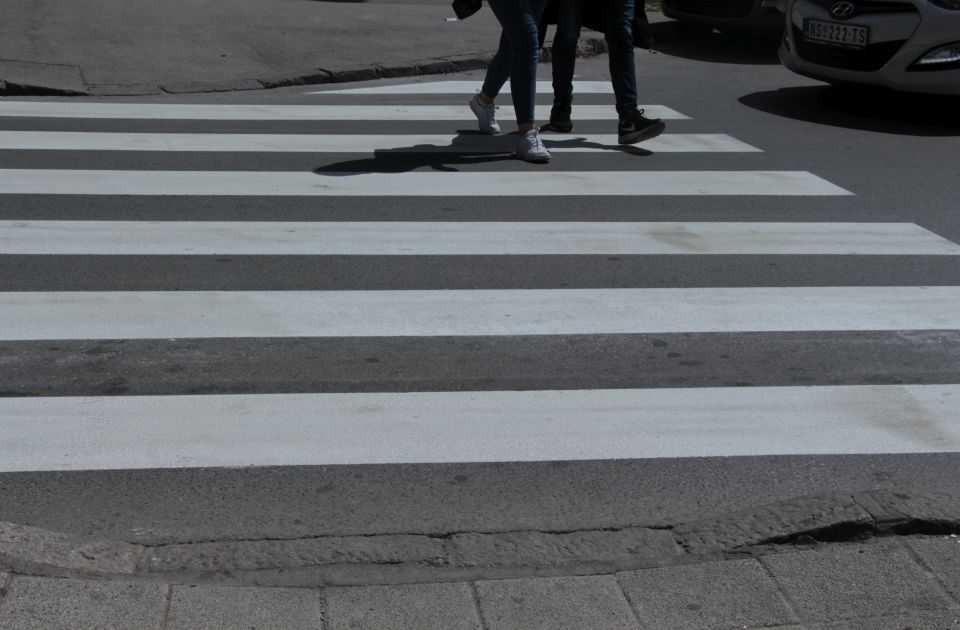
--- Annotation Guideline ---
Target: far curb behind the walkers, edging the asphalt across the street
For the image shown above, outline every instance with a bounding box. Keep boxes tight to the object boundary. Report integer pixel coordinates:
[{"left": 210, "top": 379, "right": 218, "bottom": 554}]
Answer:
[{"left": 0, "top": 37, "right": 607, "bottom": 96}]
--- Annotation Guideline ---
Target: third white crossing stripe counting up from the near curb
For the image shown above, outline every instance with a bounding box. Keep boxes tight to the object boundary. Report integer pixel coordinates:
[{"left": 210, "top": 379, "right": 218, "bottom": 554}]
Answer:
[{"left": 0, "top": 221, "right": 960, "bottom": 256}]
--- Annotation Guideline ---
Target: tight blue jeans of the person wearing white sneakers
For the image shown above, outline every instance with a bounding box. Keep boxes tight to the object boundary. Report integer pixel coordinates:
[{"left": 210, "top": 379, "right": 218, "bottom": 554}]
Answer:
[{"left": 482, "top": 0, "right": 546, "bottom": 125}]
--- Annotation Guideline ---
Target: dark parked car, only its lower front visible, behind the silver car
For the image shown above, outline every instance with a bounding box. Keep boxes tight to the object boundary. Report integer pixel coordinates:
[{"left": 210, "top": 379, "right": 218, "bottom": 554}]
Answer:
[{"left": 662, "top": 0, "right": 784, "bottom": 31}]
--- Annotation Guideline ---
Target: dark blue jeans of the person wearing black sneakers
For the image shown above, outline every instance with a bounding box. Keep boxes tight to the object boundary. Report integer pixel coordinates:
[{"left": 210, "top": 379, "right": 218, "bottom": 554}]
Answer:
[{"left": 552, "top": 0, "right": 637, "bottom": 116}]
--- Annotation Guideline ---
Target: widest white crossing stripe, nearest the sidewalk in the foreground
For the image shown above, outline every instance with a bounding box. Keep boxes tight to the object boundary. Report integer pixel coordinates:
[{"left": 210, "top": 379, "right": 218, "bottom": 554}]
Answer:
[{"left": 0, "top": 385, "right": 960, "bottom": 472}]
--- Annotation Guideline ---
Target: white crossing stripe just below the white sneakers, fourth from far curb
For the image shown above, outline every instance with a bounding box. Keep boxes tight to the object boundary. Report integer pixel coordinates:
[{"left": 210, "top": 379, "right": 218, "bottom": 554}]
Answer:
[{"left": 0, "top": 169, "right": 851, "bottom": 197}]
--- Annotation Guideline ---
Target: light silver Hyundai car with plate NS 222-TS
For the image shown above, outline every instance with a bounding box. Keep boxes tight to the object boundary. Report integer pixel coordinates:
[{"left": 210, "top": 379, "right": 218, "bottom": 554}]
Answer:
[{"left": 780, "top": 0, "right": 960, "bottom": 95}]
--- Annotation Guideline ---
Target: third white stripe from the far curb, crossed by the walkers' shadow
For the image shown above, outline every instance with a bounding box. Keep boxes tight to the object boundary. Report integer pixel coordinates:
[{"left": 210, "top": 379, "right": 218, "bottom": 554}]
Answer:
[{"left": 0, "top": 131, "right": 760, "bottom": 153}]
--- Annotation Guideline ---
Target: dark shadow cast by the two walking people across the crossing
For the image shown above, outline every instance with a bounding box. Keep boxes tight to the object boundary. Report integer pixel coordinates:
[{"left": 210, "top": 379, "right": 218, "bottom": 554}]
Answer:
[{"left": 313, "top": 128, "right": 653, "bottom": 176}]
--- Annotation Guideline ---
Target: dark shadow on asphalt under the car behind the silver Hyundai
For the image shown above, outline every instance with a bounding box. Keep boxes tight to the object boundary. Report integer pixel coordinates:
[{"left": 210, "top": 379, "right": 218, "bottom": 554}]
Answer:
[{"left": 650, "top": 21, "right": 782, "bottom": 65}]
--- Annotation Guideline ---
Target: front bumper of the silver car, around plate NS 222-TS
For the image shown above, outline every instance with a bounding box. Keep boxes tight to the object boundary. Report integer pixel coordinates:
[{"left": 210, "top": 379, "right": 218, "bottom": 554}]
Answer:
[{"left": 780, "top": 0, "right": 960, "bottom": 95}]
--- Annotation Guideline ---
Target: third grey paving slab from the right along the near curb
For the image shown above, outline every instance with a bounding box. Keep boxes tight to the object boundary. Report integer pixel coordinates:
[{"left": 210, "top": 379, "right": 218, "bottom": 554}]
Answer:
[{"left": 620, "top": 560, "right": 798, "bottom": 630}]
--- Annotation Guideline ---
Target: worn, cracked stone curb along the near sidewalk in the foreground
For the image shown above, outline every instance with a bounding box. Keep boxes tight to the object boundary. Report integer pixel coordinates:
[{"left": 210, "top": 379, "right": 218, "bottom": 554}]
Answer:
[{"left": 0, "top": 489, "right": 960, "bottom": 587}]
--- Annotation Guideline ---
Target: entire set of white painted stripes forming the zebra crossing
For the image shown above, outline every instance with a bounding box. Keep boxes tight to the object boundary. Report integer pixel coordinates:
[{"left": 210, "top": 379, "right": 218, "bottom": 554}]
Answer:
[{"left": 9, "top": 82, "right": 960, "bottom": 472}]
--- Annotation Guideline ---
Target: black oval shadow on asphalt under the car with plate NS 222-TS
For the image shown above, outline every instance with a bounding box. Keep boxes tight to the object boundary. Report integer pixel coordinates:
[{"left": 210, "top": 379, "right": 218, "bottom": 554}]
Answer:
[{"left": 740, "top": 86, "right": 960, "bottom": 137}]
